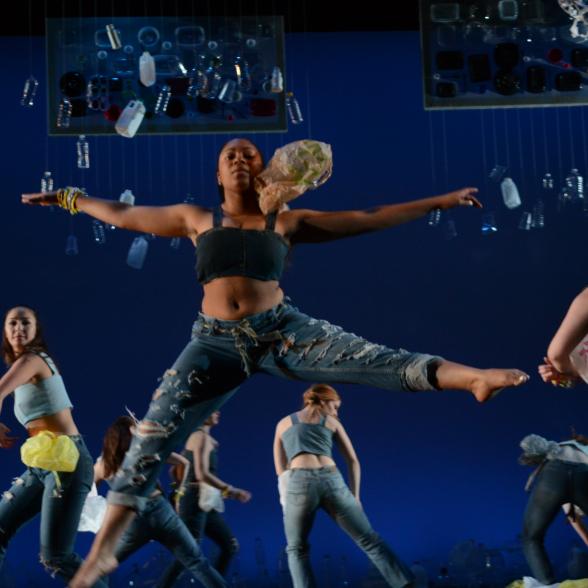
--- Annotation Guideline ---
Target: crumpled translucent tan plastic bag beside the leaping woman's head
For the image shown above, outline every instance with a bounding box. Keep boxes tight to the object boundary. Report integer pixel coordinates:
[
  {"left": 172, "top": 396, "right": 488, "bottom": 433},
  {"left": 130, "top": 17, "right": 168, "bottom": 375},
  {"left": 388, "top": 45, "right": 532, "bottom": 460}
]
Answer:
[{"left": 255, "top": 139, "right": 333, "bottom": 214}]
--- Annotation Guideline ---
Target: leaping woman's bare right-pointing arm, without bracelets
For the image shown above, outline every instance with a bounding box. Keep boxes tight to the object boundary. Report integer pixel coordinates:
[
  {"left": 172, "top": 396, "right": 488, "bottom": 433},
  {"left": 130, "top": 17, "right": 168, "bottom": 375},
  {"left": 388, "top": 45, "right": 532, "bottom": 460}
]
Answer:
[{"left": 280, "top": 188, "right": 482, "bottom": 244}]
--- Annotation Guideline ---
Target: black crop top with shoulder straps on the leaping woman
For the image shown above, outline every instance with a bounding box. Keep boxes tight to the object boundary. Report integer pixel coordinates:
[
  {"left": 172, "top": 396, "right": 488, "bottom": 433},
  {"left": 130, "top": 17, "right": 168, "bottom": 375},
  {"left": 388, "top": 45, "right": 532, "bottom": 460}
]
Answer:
[{"left": 196, "top": 206, "right": 289, "bottom": 284}]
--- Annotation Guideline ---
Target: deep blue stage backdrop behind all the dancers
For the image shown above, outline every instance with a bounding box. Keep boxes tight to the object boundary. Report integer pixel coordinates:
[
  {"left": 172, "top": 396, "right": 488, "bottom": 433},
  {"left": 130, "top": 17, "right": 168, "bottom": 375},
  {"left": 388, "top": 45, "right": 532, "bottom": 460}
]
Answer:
[{"left": 0, "top": 32, "right": 588, "bottom": 586}]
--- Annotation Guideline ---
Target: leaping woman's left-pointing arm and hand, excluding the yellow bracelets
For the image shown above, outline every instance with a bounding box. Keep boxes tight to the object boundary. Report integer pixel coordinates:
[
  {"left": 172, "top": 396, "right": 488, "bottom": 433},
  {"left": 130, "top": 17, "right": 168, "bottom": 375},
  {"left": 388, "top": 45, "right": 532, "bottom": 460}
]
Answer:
[{"left": 22, "top": 192, "right": 207, "bottom": 238}]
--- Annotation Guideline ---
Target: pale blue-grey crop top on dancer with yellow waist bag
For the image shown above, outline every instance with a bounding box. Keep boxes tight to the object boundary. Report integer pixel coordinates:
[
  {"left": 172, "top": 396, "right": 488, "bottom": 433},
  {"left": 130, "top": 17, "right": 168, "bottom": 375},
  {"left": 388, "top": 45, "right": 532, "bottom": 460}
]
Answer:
[{"left": 14, "top": 352, "right": 73, "bottom": 426}]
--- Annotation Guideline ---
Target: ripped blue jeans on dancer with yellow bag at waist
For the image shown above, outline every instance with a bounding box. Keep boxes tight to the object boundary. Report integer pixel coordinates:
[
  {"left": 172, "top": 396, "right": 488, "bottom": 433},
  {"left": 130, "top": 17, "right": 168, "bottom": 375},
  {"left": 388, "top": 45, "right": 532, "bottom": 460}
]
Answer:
[{"left": 0, "top": 435, "right": 106, "bottom": 587}]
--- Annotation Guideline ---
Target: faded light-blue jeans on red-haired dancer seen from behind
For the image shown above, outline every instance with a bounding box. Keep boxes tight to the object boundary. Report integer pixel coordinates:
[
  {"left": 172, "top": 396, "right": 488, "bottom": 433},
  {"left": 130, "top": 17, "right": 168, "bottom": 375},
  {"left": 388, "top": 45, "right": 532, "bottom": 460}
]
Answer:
[{"left": 284, "top": 466, "right": 414, "bottom": 588}]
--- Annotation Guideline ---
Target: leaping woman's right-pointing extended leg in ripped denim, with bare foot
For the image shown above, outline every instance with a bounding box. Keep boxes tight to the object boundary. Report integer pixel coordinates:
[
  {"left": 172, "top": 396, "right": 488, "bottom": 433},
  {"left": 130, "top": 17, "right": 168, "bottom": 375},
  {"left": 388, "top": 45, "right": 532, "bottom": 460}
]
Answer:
[{"left": 259, "top": 307, "right": 528, "bottom": 402}]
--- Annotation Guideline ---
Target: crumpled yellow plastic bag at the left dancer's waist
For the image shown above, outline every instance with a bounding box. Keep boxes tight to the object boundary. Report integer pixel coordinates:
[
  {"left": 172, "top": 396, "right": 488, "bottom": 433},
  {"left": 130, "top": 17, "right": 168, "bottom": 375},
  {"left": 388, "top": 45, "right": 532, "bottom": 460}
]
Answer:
[{"left": 20, "top": 431, "right": 80, "bottom": 472}]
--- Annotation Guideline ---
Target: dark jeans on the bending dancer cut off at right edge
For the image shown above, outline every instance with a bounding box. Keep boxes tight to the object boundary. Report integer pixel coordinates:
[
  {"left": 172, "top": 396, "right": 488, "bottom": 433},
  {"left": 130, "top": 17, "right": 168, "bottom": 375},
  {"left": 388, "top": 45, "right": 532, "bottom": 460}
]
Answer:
[{"left": 522, "top": 459, "right": 588, "bottom": 584}]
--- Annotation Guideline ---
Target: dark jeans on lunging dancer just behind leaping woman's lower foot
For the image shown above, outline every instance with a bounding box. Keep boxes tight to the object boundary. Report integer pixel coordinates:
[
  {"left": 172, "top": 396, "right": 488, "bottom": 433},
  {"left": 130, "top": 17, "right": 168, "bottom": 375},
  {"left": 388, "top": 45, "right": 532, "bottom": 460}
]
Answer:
[{"left": 114, "top": 496, "right": 227, "bottom": 588}]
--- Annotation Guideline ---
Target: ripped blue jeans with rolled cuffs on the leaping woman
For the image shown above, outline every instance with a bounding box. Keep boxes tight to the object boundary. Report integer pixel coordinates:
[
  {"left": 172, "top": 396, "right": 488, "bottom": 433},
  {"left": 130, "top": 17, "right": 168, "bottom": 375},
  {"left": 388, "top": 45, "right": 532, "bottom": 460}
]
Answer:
[{"left": 108, "top": 299, "right": 441, "bottom": 509}]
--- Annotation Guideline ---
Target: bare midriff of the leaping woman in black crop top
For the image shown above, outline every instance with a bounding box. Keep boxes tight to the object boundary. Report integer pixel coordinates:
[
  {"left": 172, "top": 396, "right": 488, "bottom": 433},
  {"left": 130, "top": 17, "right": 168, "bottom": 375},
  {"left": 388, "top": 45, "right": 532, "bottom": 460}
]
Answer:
[{"left": 202, "top": 276, "right": 284, "bottom": 321}]
